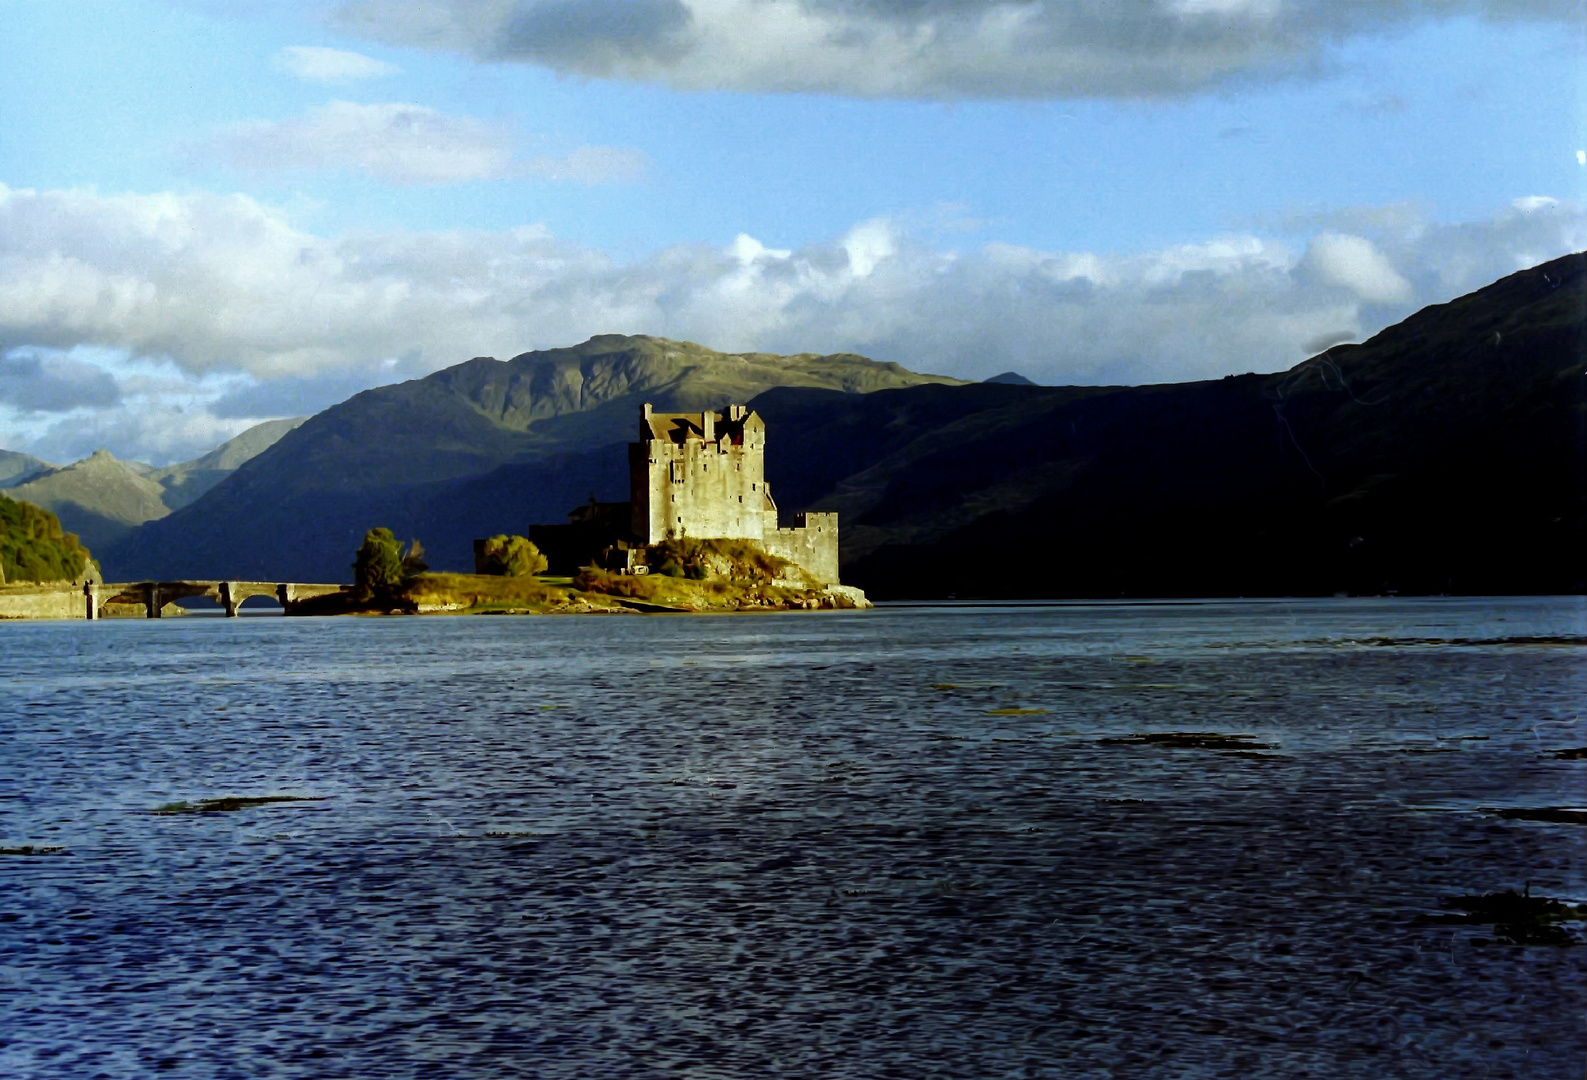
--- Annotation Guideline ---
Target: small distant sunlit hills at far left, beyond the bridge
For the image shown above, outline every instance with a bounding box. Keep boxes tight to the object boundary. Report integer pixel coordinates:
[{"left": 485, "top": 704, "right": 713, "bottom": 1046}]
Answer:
[{"left": 0, "top": 419, "right": 303, "bottom": 550}]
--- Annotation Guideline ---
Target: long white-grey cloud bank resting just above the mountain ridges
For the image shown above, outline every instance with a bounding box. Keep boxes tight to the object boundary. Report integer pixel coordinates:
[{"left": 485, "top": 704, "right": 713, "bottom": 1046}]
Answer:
[{"left": 0, "top": 177, "right": 1587, "bottom": 457}]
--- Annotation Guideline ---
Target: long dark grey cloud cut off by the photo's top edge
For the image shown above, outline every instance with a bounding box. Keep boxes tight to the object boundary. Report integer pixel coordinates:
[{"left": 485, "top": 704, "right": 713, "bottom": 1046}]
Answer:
[{"left": 333, "top": 0, "right": 1581, "bottom": 98}]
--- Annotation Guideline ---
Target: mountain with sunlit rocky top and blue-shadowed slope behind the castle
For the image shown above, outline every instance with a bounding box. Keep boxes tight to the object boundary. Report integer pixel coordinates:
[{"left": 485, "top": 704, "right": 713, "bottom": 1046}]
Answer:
[{"left": 102, "top": 335, "right": 959, "bottom": 580}]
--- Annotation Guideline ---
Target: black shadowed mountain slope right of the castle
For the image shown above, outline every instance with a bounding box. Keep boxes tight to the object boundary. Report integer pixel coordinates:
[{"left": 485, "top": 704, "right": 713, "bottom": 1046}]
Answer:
[{"left": 752, "top": 254, "right": 1587, "bottom": 598}]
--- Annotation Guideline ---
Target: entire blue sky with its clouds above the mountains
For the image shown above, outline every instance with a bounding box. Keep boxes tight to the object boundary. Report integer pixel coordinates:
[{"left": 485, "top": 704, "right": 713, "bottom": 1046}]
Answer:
[{"left": 0, "top": 0, "right": 1587, "bottom": 465}]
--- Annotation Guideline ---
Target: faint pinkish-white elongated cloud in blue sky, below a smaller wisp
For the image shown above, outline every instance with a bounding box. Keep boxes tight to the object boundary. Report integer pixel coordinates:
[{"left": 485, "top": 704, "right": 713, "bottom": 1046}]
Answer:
[{"left": 198, "top": 101, "right": 513, "bottom": 184}]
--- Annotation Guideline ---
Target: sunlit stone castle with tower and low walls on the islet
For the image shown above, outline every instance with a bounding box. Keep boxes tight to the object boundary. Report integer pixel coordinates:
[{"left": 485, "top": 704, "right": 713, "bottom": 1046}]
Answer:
[{"left": 530, "top": 404, "right": 838, "bottom": 585}]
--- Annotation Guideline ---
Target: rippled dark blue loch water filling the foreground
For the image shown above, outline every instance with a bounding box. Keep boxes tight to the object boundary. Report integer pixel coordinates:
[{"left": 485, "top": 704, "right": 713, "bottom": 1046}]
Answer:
[{"left": 0, "top": 598, "right": 1587, "bottom": 1080}]
